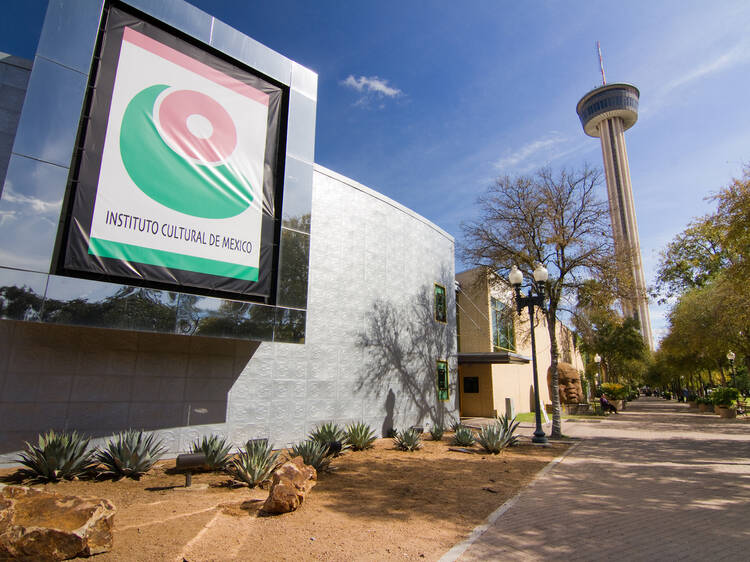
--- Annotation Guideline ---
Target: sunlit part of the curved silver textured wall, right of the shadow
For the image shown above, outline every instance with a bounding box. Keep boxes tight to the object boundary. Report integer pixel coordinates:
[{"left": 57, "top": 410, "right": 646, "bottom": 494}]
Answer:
[{"left": 229, "top": 166, "right": 458, "bottom": 446}]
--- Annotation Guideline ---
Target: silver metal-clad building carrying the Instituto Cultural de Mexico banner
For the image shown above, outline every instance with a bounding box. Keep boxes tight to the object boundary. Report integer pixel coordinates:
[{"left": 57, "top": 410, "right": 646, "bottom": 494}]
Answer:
[{"left": 0, "top": 0, "right": 458, "bottom": 463}]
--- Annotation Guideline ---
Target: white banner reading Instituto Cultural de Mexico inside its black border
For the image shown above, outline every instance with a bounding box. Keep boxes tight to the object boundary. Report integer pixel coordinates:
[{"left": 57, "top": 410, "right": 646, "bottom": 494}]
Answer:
[{"left": 89, "top": 27, "right": 270, "bottom": 281}]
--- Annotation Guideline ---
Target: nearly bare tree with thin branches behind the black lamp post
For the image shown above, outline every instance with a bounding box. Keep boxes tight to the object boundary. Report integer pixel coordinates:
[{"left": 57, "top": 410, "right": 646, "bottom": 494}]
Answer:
[{"left": 462, "top": 166, "right": 617, "bottom": 437}]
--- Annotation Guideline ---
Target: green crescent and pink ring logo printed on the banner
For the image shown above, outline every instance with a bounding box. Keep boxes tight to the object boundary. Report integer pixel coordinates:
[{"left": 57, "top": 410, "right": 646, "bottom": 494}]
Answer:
[{"left": 120, "top": 84, "right": 253, "bottom": 219}]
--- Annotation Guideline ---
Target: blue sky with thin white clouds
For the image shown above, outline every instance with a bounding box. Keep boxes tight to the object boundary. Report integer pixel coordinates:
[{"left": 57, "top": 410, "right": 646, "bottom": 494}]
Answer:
[{"left": 0, "top": 0, "right": 750, "bottom": 337}]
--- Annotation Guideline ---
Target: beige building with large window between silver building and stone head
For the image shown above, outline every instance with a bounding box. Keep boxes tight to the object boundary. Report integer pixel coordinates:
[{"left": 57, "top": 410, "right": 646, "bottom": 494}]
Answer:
[{"left": 456, "top": 268, "right": 584, "bottom": 417}]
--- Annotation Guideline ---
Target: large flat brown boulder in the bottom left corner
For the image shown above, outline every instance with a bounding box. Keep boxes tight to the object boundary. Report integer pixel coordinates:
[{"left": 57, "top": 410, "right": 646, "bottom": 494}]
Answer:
[{"left": 0, "top": 486, "right": 115, "bottom": 560}]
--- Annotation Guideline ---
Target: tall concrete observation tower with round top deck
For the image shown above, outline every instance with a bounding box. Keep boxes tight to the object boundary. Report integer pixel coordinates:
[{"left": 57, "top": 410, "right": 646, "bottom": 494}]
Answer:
[{"left": 576, "top": 81, "right": 654, "bottom": 349}]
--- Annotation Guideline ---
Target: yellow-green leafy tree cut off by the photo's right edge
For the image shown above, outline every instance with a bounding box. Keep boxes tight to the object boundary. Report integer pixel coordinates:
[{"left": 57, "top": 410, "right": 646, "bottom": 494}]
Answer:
[{"left": 655, "top": 166, "right": 750, "bottom": 376}]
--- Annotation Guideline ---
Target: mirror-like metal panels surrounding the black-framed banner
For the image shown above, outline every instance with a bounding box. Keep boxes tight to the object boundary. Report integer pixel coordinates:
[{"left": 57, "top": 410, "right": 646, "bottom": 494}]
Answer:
[{"left": 0, "top": 0, "right": 318, "bottom": 343}]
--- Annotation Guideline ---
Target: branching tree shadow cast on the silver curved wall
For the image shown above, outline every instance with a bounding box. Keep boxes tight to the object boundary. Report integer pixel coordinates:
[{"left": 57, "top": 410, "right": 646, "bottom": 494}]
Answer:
[{"left": 357, "top": 275, "right": 458, "bottom": 435}]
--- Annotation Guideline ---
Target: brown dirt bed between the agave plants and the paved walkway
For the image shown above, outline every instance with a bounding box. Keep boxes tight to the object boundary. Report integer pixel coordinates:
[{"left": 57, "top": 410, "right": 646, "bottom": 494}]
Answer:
[{"left": 2, "top": 436, "right": 567, "bottom": 562}]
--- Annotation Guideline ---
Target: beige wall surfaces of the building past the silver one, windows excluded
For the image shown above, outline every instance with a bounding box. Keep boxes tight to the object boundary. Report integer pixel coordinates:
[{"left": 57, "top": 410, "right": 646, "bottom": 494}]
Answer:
[{"left": 456, "top": 269, "right": 583, "bottom": 416}]
